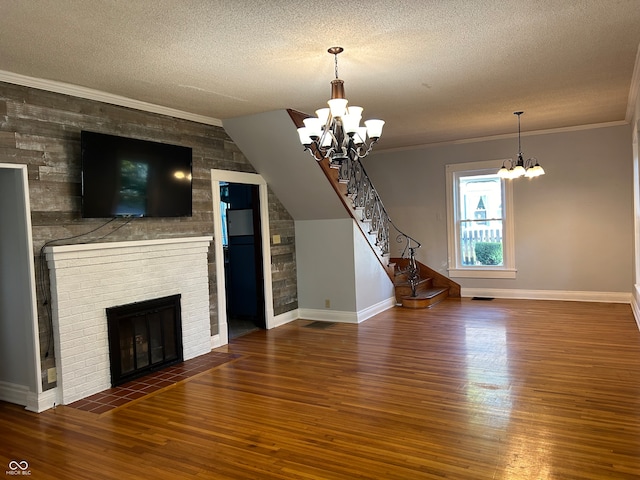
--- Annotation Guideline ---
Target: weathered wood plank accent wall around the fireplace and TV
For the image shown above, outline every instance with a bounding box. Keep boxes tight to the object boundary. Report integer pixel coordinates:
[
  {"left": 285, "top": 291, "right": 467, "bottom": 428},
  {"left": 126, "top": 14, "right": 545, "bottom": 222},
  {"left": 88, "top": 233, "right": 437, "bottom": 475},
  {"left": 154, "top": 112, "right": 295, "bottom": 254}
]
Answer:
[{"left": 0, "top": 82, "right": 298, "bottom": 390}]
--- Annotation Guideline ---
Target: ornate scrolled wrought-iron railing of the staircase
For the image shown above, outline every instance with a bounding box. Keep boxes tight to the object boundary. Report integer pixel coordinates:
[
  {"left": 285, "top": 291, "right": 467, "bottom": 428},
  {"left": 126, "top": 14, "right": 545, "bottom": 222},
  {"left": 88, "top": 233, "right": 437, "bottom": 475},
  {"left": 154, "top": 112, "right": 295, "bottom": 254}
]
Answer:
[{"left": 331, "top": 155, "right": 421, "bottom": 297}]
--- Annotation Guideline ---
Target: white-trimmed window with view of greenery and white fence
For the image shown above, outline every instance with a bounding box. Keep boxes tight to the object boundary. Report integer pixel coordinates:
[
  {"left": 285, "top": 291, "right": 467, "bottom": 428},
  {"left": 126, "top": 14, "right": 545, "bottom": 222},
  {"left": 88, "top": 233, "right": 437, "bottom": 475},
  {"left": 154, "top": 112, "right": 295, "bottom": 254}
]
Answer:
[{"left": 446, "top": 160, "right": 516, "bottom": 278}]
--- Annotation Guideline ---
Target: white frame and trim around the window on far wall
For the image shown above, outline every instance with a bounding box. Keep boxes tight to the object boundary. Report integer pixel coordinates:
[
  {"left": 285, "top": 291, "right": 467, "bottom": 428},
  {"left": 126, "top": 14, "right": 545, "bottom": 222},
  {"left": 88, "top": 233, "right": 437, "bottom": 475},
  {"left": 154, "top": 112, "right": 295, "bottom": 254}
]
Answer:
[{"left": 445, "top": 160, "right": 517, "bottom": 278}]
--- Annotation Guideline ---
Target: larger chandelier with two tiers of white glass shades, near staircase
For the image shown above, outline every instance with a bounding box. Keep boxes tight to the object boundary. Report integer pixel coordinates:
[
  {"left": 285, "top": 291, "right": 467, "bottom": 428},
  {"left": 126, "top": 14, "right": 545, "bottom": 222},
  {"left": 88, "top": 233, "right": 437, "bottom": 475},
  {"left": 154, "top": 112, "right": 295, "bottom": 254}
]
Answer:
[{"left": 298, "top": 47, "right": 384, "bottom": 168}]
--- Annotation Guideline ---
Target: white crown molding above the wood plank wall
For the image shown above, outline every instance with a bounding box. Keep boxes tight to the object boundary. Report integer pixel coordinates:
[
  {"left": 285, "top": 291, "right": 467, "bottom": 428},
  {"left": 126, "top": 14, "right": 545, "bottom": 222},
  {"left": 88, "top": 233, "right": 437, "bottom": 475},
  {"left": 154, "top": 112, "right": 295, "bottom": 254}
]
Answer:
[{"left": 0, "top": 70, "right": 222, "bottom": 127}]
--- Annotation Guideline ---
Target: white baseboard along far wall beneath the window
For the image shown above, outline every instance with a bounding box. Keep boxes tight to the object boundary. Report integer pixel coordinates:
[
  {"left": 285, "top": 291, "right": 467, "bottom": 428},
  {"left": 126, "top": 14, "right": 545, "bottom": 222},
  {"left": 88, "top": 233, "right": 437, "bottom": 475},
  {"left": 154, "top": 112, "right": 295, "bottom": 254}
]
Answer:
[{"left": 460, "top": 287, "right": 631, "bottom": 303}]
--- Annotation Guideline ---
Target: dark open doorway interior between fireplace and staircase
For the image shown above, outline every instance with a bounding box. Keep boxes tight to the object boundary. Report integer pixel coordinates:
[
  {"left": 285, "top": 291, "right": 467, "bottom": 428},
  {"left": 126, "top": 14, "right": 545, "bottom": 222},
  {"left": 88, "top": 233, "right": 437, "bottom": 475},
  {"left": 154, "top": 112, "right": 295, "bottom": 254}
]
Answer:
[{"left": 220, "top": 182, "right": 266, "bottom": 338}]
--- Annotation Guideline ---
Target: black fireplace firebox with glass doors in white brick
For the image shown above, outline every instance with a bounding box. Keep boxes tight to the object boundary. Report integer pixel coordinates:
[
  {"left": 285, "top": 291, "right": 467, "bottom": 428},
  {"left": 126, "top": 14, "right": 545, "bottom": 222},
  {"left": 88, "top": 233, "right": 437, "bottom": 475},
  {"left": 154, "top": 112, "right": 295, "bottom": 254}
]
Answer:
[{"left": 106, "top": 295, "right": 183, "bottom": 387}]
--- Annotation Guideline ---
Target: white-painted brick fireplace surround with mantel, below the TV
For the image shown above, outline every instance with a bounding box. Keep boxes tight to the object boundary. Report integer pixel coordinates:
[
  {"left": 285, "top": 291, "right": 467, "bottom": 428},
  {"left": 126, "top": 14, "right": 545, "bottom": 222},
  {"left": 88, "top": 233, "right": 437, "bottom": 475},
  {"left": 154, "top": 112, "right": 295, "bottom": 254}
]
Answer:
[{"left": 46, "top": 237, "right": 212, "bottom": 404}]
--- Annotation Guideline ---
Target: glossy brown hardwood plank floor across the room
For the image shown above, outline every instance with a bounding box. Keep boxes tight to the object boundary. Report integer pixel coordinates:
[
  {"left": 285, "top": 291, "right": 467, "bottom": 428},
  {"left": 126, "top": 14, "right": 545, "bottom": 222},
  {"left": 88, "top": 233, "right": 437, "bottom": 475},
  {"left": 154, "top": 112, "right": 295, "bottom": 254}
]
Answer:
[{"left": 0, "top": 299, "right": 640, "bottom": 480}]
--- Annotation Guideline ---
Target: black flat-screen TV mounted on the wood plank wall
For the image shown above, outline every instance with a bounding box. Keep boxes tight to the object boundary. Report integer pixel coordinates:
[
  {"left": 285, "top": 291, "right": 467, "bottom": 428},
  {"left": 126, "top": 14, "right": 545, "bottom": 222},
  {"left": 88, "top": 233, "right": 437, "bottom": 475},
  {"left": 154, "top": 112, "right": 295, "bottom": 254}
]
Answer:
[{"left": 81, "top": 131, "right": 192, "bottom": 218}]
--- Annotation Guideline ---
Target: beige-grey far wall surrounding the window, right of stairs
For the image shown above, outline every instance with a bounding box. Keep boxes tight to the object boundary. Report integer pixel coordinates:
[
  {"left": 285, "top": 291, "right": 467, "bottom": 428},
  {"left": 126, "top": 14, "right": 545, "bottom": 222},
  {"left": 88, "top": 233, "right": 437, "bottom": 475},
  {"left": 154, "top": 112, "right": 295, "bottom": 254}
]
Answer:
[{"left": 364, "top": 125, "right": 633, "bottom": 295}]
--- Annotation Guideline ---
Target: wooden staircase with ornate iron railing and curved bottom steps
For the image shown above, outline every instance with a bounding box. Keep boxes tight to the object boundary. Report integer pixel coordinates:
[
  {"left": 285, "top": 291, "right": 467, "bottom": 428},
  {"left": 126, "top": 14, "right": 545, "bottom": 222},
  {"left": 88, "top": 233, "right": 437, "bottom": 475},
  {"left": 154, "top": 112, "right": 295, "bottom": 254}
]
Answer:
[{"left": 287, "top": 110, "right": 460, "bottom": 308}]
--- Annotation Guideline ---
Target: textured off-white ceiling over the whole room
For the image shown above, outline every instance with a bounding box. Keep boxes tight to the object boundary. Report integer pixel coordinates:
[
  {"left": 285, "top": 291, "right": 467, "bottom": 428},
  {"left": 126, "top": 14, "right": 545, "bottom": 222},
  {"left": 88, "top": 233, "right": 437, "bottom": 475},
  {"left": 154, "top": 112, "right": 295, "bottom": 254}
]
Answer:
[{"left": 0, "top": 0, "right": 640, "bottom": 149}]
